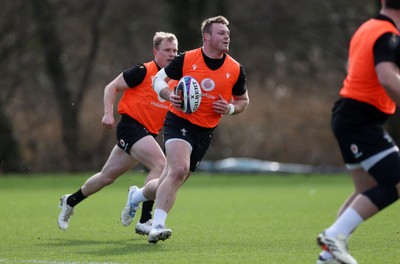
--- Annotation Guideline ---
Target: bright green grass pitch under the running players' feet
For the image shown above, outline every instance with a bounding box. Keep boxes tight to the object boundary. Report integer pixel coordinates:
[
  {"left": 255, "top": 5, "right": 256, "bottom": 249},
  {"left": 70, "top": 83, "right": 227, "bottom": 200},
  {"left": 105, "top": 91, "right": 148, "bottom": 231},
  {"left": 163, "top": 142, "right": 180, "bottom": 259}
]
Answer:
[{"left": 0, "top": 172, "right": 400, "bottom": 264}]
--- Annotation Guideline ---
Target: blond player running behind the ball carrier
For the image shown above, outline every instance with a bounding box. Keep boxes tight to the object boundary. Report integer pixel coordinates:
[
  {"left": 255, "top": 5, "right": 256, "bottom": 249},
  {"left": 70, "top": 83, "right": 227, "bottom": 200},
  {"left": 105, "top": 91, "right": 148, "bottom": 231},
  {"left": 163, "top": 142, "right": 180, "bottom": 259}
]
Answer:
[{"left": 58, "top": 32, "right": 178, "bottom": 235}]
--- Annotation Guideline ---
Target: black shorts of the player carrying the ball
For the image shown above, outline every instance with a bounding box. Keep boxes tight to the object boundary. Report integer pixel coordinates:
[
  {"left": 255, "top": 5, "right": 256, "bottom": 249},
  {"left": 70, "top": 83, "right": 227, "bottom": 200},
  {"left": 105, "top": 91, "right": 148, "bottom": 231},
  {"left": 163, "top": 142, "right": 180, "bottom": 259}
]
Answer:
[{"left": 164, "top": 112, "right": 215, "bottom": 172}]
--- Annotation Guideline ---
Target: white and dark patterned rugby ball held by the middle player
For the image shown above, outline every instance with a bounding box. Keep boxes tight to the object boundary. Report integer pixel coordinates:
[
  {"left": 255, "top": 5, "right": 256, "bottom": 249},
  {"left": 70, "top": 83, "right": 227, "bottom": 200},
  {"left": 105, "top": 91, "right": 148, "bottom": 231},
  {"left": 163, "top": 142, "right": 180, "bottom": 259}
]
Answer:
[{"left": 175, "top": 76, "right": 202, "bottom": 114}]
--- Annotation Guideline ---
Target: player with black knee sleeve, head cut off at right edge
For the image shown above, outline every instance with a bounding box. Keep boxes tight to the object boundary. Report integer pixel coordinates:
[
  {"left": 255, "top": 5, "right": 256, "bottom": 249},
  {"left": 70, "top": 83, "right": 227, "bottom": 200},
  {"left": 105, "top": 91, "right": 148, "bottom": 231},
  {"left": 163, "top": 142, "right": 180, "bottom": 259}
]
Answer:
[{"left": 317, "top": 0, "right": 400, "bottom": 264}]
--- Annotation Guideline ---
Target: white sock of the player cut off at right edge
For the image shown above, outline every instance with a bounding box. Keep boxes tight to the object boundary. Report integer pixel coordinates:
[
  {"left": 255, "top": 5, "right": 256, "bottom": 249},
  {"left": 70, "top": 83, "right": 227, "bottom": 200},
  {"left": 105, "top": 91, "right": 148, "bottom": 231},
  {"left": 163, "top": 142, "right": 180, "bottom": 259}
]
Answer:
[{"left": 325, "top": 207, "right": 364, "bottom": 237}]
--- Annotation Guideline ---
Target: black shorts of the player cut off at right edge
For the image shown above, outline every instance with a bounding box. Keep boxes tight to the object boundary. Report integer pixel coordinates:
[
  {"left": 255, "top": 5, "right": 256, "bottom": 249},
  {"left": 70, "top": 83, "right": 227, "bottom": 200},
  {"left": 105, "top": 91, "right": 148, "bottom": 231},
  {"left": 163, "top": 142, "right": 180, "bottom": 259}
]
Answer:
[{"left": 332, "top": 98, "right": 395, "bottom": 165}]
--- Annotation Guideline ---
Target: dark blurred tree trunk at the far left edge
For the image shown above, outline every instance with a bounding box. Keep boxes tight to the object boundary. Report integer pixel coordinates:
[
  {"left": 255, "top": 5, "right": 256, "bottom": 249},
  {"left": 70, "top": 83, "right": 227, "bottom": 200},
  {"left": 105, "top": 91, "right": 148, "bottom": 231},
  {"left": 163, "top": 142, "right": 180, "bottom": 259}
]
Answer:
[{"left": 0, "top": 1, "right": 28, "bottom": 173}]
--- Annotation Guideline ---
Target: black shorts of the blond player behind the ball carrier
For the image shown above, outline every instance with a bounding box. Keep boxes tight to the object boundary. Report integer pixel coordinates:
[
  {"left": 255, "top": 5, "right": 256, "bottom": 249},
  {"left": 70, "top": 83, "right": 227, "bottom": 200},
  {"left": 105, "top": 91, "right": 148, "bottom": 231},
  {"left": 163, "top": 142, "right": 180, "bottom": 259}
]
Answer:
[{"left": 117, "top": 115, "right": 157, "bottom": 155}]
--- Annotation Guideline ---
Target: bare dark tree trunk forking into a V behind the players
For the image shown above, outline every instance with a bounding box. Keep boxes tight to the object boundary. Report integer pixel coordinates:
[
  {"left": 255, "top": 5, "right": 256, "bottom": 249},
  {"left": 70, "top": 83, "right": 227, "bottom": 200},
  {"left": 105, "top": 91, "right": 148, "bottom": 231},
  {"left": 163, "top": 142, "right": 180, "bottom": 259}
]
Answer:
[{"left": 31, "top": 0, "right": 107, "bottom": 171}]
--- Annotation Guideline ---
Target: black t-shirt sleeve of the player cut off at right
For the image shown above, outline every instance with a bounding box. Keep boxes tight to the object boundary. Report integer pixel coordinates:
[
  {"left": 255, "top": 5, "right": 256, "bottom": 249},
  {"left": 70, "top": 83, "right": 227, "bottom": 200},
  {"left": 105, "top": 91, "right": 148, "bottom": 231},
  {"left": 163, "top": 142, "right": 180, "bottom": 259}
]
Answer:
[{"left": 373, "top": 32, "right": 400, "bottom": 66}]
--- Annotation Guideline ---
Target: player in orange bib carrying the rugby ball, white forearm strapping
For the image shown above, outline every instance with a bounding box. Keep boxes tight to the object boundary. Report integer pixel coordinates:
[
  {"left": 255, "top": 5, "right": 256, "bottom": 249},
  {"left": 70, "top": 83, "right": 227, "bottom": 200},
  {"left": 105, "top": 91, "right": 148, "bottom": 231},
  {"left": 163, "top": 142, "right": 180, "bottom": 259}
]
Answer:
[{"left": 122, "top": 16, "right": 249, "bottom": 243}]
